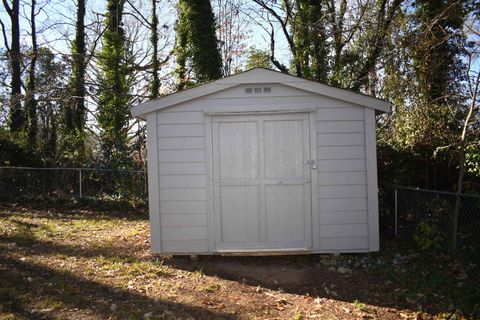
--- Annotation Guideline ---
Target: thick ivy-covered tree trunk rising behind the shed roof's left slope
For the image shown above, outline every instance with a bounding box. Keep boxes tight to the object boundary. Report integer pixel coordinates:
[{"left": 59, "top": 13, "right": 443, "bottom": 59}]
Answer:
[{"left": 176, "top": 0, "right": 222, "bottom": 89}]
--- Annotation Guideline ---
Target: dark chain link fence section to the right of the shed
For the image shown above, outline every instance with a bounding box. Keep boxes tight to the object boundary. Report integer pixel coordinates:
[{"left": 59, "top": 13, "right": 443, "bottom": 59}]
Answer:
[{"left": 394, "top": 187, "right": 480, "bottom": 252}]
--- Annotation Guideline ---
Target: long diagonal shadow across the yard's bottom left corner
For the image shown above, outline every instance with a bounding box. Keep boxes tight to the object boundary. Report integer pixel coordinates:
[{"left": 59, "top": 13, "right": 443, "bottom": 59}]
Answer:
[{"left": 0, "top": 254, "right": 232, "bottom": 319}]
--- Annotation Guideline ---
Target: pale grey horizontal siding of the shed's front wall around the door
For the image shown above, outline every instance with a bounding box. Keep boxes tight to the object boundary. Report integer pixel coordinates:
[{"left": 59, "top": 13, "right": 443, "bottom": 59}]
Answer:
[{"left": 148, "top": 84, "right": 369, "bottom": 253}]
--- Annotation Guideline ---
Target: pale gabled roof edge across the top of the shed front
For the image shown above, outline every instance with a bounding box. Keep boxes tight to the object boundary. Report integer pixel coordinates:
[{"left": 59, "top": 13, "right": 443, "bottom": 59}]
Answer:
[{"left": 131, "top": 68, "right": 390, "bottom": 118}]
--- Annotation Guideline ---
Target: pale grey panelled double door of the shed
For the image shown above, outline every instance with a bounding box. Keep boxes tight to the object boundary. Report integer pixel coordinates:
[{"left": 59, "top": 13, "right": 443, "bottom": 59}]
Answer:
[{"left": 212, "top": 113, "right": 312, "bottom": 252}]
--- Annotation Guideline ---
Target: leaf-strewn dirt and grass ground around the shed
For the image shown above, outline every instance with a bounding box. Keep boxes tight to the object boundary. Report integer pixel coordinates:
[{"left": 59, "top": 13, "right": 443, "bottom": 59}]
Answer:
[{"left": 0, "top": 205, "right": 480, "bottom": 319}]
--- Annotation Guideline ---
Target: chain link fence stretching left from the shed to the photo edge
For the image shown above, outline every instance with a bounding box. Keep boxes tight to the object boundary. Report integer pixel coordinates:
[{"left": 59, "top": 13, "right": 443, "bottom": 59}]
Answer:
[{"left": 0, "top": 167, "right": 148, "bottom": 203}]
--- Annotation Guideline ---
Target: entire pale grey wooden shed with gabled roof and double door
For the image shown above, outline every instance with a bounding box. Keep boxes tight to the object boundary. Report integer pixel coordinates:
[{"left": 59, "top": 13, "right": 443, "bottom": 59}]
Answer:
[{"left": 131, "top": 68, "right": 389, "bottom": 254}]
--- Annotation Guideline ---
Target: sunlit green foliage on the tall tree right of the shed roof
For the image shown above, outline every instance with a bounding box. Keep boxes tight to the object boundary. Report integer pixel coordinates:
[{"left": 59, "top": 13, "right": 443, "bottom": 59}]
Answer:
[{"left": 385, "top": 0, "right": 465, "bottom": 156}]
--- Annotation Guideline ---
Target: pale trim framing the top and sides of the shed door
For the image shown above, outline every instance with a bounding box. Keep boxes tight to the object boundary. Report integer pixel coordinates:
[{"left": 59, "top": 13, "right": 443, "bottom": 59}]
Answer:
[{"left": 204, "top": 106, "right": 320, "bottom": 254}]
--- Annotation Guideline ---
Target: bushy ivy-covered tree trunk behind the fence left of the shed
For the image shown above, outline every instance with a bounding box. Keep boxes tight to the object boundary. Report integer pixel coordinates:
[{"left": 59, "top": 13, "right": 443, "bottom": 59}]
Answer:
[{"left": 97, "top": 0, "right": 131, "bottom": 168}]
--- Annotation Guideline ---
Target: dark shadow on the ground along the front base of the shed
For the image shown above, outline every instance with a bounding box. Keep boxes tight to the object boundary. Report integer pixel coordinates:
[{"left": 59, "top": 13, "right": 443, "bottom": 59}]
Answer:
[{"left": 167, "top": 239, "right": 480, "bottom": 317}]
